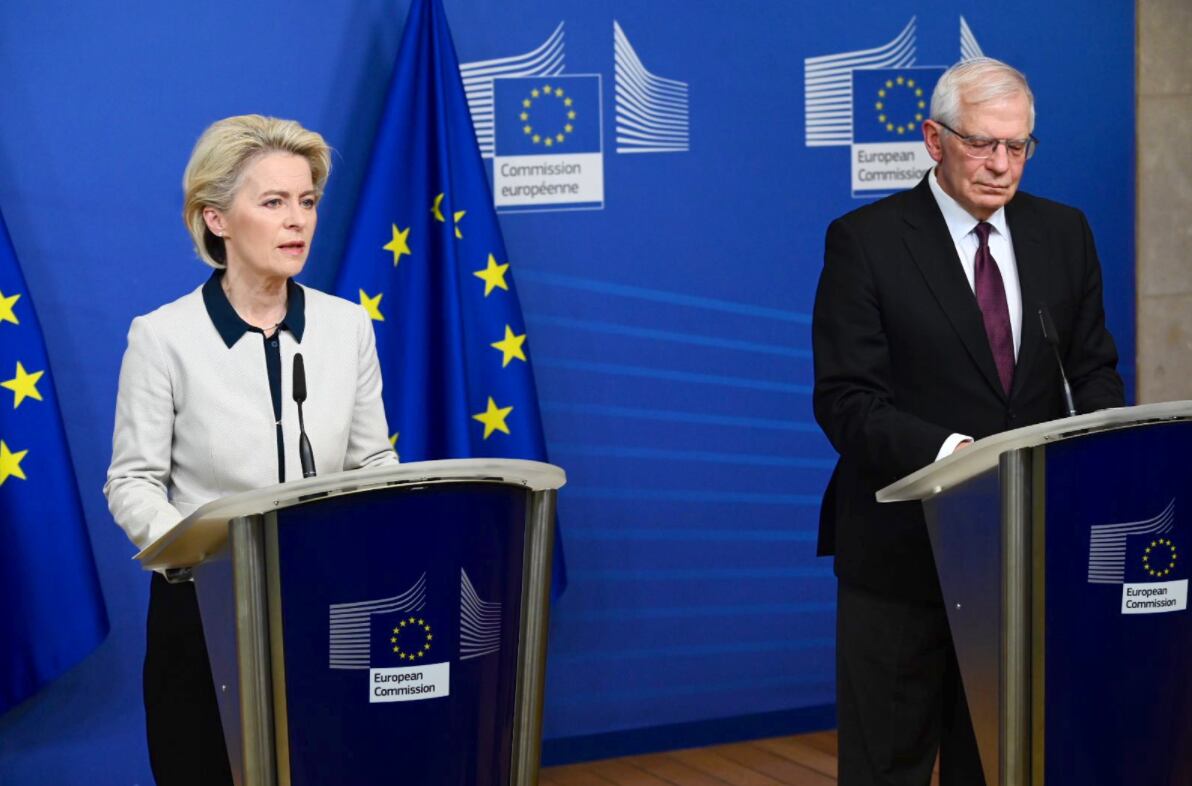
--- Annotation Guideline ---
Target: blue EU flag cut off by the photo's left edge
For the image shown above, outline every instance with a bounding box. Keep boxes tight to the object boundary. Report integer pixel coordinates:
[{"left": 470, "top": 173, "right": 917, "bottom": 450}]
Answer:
[{"left": 0, "top": 208, "right": 107, "bottom": 713}]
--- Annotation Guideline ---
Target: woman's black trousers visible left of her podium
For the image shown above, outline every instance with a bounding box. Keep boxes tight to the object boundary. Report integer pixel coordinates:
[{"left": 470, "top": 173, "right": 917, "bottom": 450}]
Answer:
[{"left": 143, "top": 573, "right": 232, "bottom": 786}]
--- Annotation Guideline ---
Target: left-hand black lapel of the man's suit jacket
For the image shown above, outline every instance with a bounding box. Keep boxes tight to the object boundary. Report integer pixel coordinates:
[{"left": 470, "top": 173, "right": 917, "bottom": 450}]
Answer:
[{"left": 902, "top": 173, "right": 1006, "bottom": 398}]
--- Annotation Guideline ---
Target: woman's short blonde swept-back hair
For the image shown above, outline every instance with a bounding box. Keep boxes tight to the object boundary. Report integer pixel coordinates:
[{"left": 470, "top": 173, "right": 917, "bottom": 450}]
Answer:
[{"left": 182, "top": 115, "right": 331, "bottom": 267}]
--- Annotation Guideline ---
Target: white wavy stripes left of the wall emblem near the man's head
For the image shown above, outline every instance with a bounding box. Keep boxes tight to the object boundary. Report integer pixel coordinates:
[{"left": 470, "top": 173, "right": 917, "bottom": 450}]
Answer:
[{"left": 803, "top": 17, "right": 915, "bottom": 148}]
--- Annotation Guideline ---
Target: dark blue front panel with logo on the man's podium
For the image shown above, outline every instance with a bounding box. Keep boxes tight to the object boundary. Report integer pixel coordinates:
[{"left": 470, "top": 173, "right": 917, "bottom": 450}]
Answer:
[{"left": 1042, "top": 423, "right": 1192, "bottom": 786}]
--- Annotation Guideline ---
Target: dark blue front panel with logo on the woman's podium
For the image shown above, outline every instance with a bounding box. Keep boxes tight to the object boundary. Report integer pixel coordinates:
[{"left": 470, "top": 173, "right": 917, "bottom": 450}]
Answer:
[{"left": 268, "top": 483, "right": 530, "bottom": 786}]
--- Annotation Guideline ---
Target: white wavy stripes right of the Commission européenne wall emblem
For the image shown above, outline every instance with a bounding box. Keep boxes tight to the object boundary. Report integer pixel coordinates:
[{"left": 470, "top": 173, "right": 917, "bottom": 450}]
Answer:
[{"left": 613, "top": 19, "right": 690, "bottom": 153}]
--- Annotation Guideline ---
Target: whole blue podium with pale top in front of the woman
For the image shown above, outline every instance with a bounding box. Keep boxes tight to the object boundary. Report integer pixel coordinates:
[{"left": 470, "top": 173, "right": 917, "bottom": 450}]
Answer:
[{"left": 137, "top": 459, "right": 565, "bottom": 786}]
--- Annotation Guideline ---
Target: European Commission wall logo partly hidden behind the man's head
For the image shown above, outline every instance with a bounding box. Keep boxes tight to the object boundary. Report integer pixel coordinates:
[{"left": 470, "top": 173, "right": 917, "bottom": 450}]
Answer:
[{"left": 803, "top": 17, "right": 982, "bottom": 199}]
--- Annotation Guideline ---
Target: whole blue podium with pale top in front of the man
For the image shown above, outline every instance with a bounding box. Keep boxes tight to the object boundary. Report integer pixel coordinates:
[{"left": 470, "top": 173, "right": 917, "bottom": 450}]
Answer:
[{"left": 877, "top": 402, "right": 1192, "bottom": 786}]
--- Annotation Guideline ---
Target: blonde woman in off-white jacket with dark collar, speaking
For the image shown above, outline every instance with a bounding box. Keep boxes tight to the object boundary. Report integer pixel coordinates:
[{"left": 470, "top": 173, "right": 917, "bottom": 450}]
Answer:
[{"left": 104, "top": 115, "right": 397, "bottom": 786}]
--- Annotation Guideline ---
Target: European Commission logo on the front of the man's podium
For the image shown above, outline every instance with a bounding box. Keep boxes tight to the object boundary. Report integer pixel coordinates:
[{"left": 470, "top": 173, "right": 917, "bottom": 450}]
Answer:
[{"left": 1088, "top": 499, "right": 1190, "bottom": 614}]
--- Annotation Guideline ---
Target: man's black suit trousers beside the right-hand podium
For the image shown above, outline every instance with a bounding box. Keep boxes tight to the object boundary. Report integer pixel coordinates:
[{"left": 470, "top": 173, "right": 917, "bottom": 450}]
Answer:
[{"left": 836, "top": 581, "right": 985, "bottom": 786}]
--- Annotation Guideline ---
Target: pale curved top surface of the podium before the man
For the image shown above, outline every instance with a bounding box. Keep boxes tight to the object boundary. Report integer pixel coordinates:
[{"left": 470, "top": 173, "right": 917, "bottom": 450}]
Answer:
[{"left": 877, "top": 401, "right": 1192, "bottom": 502}]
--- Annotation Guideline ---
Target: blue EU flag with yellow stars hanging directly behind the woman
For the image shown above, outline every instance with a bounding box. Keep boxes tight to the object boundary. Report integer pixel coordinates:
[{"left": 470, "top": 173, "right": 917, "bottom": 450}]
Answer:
[{"left": 336, "top": 0, "right": 566, "bottom": 598}]
